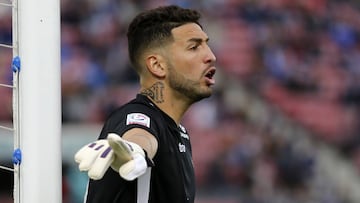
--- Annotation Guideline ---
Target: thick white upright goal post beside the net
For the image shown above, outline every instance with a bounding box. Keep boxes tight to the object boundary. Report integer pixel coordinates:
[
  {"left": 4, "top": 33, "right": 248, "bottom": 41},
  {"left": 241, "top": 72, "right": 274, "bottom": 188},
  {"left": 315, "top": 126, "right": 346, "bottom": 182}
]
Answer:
[{"left": 13, "top": 0, "right": 62, "bottom": 203}]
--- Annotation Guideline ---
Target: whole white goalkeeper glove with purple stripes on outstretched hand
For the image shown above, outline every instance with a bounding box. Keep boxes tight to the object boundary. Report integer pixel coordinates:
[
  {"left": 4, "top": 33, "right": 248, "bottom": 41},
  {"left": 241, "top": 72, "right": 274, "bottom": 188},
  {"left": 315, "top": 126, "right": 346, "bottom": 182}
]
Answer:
[{"left": 75, "top": 133, "right": 153, "bottom": 181}]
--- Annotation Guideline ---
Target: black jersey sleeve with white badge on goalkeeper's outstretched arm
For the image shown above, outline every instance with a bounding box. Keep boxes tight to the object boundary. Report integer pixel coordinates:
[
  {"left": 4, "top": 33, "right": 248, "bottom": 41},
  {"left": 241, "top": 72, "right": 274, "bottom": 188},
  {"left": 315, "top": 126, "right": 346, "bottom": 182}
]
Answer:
[{"left": 99, "top": 103, "right": 160, "bottom": 140}]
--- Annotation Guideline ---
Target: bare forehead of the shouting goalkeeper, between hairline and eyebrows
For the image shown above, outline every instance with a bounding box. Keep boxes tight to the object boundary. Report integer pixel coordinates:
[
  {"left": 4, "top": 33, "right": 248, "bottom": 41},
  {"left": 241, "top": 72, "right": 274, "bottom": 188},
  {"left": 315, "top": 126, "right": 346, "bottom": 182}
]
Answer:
[{"left": 172, "top": 23, "right": 208, "bottom": 41}]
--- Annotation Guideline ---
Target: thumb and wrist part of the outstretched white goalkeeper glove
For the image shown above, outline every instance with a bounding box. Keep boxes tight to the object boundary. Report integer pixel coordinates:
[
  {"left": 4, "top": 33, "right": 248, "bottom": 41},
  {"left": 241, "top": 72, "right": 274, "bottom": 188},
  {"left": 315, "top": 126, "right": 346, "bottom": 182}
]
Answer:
[{"left": 107, "top": 133, "right": 152, "bottom": 181}]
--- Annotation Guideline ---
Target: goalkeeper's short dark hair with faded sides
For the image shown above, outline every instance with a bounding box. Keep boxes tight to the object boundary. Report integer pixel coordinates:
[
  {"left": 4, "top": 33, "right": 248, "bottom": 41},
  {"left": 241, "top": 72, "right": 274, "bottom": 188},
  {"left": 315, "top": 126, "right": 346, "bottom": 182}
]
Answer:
[{"left": 127, "top": 5, "right": 201, "bottom": 72}]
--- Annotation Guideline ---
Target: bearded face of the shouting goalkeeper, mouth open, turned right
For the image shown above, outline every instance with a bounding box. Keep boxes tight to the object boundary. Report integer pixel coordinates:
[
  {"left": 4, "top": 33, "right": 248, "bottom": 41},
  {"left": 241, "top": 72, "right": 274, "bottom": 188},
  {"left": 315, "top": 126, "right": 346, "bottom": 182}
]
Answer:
[{"left": 166, "top": 23, "right": 216, "bottom": 102}]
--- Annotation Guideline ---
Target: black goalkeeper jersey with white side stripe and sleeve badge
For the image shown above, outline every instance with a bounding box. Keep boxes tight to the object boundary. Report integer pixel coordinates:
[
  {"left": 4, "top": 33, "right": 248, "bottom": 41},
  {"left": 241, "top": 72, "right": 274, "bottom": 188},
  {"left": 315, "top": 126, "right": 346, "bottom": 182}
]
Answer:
[{"left": 85, "top": 94, "right": 195, "bottom": 203}]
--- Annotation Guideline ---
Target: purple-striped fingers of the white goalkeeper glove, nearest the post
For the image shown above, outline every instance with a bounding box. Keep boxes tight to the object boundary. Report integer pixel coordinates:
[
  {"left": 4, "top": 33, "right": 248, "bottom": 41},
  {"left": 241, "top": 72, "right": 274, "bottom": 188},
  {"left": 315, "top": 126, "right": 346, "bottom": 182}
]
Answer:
[{"left": 75, "top": 140, "right": 114, "bottom": 180}]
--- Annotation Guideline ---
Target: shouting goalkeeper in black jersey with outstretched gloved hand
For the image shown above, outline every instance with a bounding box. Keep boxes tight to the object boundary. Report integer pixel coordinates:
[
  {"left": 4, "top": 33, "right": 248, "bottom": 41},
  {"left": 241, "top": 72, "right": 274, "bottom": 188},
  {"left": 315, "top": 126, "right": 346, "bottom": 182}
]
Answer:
[{"left": 75, "top": 6, "right": 216, "bottom": 203}]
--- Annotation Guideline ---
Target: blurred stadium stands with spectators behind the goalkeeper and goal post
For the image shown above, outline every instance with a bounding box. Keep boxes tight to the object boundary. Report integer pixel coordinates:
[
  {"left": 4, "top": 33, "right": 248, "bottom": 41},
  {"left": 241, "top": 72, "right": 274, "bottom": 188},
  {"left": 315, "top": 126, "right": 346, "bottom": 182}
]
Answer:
[{"left": 0, "top": 0, "right": 360, "bottom": 203}]
